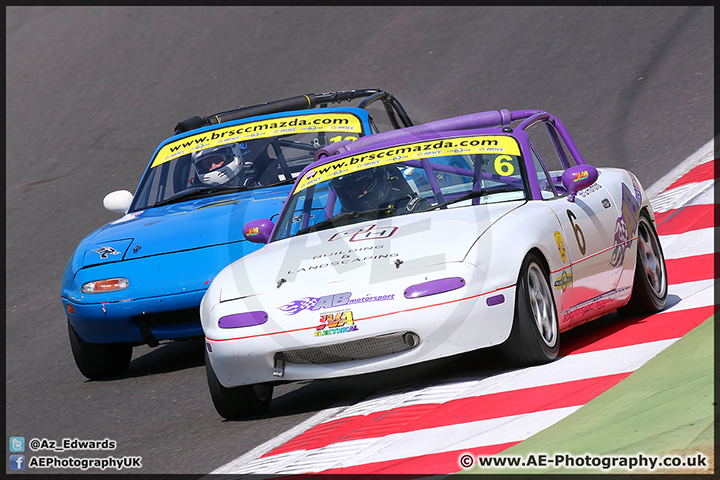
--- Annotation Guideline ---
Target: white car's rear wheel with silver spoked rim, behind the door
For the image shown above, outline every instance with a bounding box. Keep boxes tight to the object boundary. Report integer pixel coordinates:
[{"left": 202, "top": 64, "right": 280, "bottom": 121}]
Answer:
[{"left": 618, "top": 211, "right": 668, "bottom": 317}]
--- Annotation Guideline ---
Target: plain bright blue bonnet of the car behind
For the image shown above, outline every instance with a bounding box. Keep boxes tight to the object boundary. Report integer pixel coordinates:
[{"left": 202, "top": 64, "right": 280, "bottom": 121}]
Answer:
[{"left": 83, "top": 185, "right": 292, "bottom": 267}]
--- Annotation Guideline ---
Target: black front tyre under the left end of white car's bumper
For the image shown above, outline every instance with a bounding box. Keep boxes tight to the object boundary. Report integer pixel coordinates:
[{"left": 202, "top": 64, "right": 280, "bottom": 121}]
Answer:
[{"left": 205, "top": 350, "right": 273, "bottom": 420}]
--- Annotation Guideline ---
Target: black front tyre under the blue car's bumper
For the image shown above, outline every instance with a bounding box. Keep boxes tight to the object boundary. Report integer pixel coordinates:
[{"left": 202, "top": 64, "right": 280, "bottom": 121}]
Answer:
[{"left": 68, "top": 320, "right": 132, "bottom": 380}]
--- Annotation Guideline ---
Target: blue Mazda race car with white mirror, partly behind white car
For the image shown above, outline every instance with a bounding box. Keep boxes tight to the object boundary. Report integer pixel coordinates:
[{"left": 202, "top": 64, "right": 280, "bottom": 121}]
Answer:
[{"left": 61, "top": 89, "right": 412, "bottom": 379}]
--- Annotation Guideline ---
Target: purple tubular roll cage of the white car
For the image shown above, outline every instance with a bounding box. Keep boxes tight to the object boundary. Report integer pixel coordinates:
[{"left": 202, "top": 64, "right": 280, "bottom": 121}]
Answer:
[{"left": 270, "top": 109, "right": 585, "bottom": 242}]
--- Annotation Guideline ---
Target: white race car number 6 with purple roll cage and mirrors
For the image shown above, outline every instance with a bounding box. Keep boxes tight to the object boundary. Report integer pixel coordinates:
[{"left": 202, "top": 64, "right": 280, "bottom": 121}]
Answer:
[{"left": 200, "top": 110, "right": 667, "bottom": 419}]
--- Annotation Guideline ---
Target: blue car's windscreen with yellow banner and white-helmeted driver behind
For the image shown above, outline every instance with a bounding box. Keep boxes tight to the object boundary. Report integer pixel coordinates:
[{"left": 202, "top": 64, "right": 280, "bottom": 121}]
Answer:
[{"left": 130, "top": 109, "right": 367, "bottom": 212}]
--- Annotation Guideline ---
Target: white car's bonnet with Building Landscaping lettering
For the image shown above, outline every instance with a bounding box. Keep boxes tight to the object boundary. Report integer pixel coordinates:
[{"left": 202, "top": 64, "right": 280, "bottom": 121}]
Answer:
[{"left": 220, "top": 201, "right": 523, "bottom": 301}]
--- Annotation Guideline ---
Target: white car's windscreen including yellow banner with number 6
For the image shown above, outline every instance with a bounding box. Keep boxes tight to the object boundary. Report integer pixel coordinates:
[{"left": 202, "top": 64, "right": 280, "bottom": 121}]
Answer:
[{"left": 273, "top": 135, "right": 526, "bottom": 240}]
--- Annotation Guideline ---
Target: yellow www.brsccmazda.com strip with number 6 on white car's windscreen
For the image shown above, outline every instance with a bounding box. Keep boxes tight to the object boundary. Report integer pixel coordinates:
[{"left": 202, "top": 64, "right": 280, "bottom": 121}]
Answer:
[{"left": 293, "top": 135, "right": 520, "bottom": 194}]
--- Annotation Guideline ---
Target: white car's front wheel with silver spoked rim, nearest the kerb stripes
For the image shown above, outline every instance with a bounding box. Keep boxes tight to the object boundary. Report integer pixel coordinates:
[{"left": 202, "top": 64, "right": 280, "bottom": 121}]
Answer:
[{"left": 501, "top": 252, "right": 560, "bottom": 366}]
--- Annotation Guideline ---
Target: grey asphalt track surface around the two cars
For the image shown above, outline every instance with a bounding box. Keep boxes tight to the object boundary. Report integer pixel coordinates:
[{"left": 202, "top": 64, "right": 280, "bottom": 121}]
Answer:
[{"left": 5, "top": 7, "right": 714, "bottom": 474}]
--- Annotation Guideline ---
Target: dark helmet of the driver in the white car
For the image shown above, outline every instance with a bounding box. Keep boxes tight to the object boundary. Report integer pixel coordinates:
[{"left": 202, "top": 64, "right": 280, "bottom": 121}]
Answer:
[{"left": 330, "top": 167, "right": 390, "bottom": 212}]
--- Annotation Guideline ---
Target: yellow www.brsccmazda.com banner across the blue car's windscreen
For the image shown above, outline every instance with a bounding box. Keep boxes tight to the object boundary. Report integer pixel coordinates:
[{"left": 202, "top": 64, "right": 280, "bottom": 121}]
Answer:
[{"left": 150, "top": 112, "right": 363, "bottom": 168}]
